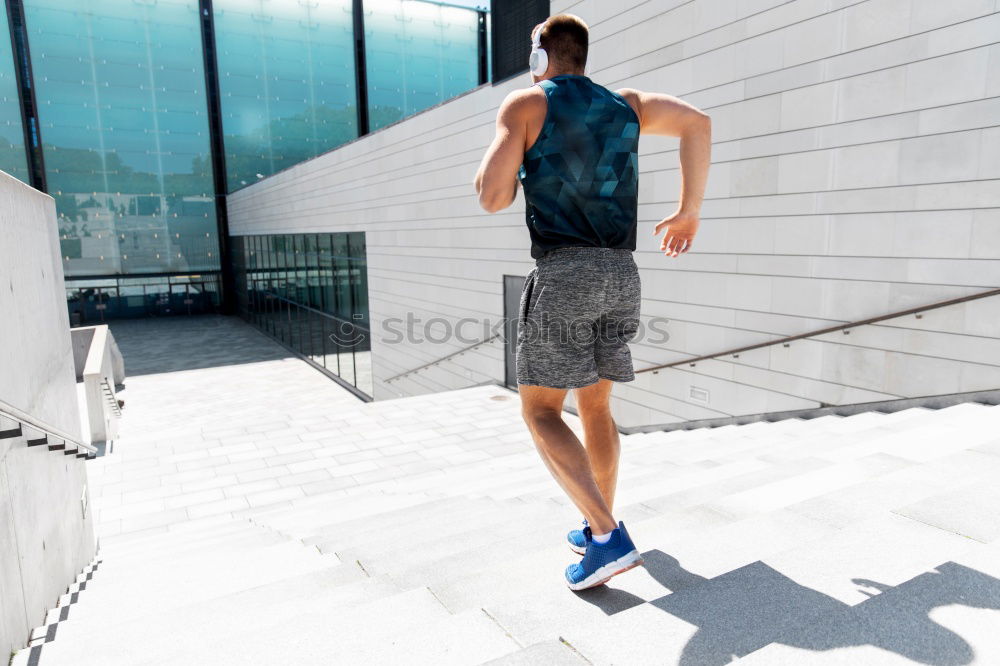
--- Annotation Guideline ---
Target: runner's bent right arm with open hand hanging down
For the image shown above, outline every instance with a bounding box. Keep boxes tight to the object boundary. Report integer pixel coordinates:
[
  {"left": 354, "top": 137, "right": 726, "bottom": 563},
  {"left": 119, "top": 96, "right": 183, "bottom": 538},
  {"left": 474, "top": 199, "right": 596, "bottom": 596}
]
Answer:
[{"left": 618, "top": 88, "right": 712, "bottom": 257}]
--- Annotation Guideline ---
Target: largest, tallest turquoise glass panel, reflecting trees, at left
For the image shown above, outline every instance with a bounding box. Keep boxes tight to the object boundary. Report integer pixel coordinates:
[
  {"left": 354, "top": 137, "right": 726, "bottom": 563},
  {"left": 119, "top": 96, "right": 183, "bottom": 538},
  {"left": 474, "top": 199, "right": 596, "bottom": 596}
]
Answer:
[{"left": 24, "top": 0, "right": 219, "bottom": 275}]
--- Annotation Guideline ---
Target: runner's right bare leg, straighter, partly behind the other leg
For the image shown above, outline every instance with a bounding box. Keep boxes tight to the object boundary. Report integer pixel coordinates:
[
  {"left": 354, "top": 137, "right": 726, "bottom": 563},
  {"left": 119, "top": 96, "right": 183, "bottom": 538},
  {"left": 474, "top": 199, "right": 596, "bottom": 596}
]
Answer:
[{"left": 576, "top": 379, "right": 621, "bottom": 511}]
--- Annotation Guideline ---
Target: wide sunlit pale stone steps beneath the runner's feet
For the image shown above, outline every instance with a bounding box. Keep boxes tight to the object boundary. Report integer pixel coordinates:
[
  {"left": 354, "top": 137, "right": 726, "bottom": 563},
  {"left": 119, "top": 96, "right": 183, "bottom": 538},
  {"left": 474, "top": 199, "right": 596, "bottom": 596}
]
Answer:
[{"left": 13, "top": 387, "right": 1000, "bottom": 666}]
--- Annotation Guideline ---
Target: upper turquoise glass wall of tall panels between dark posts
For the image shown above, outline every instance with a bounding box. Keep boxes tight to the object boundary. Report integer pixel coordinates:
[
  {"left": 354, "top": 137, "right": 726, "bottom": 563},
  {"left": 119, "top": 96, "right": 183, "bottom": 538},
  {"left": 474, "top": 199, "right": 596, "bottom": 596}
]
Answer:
[{"left": 0, "top": 0, "right": 488, "bottom": 284}]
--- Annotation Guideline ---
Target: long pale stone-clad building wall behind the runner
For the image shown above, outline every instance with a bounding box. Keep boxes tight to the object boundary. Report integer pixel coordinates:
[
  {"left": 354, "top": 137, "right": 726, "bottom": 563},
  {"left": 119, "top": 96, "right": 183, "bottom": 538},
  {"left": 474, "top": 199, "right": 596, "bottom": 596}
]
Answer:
[{"left": 229, "top": 0, "right": 1000, "bottom": 426}]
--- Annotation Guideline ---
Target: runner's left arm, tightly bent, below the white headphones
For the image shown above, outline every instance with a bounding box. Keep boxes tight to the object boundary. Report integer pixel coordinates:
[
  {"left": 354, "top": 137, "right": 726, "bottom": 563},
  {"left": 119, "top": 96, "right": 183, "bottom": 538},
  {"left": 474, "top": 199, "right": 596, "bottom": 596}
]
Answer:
[{"left": 475, "top": 90, "right": 527, "bottom": 213}]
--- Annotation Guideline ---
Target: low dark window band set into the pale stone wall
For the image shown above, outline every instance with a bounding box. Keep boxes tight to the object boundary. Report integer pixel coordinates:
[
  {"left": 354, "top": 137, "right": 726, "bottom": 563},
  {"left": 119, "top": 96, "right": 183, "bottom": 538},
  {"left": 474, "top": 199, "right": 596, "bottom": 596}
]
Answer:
[{"left": 231, "top": 232, "right": 373, "bottom": 397}]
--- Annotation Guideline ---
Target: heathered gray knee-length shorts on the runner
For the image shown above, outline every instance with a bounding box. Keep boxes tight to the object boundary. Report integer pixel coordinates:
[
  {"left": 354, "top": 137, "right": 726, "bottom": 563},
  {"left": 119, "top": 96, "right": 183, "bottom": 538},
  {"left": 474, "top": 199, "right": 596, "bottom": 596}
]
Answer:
[{"left": 517, "top": 247, "right": 640, "bottom": 389}]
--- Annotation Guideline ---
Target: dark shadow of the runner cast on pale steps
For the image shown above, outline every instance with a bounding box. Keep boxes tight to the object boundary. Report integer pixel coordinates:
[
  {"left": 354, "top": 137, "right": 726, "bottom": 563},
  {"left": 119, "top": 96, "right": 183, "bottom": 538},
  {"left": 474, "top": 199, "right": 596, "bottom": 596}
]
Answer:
[{"left": 580, "top": 550, "right": 1000, "bottom": 666}]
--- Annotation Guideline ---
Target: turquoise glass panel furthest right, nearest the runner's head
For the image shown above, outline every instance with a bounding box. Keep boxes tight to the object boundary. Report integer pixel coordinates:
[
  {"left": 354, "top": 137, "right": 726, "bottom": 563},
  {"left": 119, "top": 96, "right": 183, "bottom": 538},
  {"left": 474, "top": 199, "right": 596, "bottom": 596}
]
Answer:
[{"left": 365, "top": 0, "right": 479, "bottom": 131}]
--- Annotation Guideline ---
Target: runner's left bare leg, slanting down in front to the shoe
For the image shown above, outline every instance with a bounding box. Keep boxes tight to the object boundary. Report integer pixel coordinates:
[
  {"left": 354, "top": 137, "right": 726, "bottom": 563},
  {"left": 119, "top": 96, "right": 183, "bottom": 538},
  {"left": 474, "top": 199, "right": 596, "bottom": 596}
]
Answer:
[{"left": 518, "top": 384, "right": 618, "bottom": 534}]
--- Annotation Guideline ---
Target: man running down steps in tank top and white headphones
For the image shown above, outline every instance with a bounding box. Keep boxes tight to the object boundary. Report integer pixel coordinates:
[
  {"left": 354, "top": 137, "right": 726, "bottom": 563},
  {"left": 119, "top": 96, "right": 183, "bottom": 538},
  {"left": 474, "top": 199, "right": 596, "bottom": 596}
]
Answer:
[{"left": 475, "top": 14, "right": 711, "bottom": 590}]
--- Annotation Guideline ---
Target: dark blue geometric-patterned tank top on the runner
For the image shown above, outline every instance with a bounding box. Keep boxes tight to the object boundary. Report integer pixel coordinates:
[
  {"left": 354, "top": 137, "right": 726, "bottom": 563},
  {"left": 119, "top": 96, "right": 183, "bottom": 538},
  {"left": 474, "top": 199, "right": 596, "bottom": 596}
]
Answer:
[{"left": 518, "top": 74, "right": 639, "bottom": 259}]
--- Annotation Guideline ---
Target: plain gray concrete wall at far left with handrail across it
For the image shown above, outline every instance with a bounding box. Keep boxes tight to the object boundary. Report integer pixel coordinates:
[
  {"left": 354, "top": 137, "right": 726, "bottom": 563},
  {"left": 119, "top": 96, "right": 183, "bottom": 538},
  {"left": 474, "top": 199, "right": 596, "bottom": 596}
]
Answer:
[{"left": 0, "top": 172, "right": 96, "bottom": 660}]
